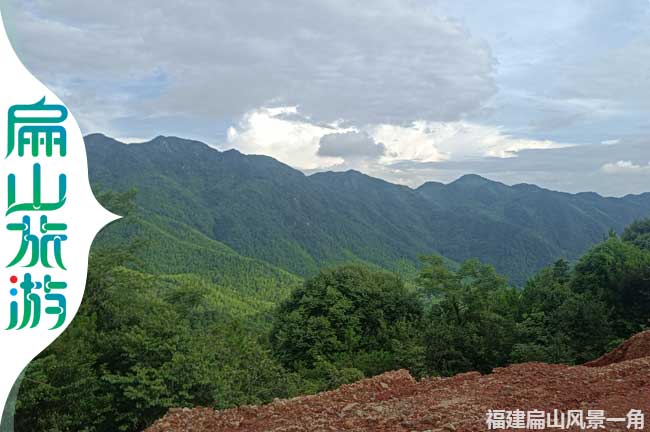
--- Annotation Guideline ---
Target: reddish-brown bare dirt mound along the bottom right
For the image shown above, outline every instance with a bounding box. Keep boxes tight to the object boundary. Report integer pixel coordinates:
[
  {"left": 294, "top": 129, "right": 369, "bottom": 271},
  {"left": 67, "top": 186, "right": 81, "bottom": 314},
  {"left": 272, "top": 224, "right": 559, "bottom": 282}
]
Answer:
[{"left": 147, "top": 334, "right": 650, "bottom": 432}]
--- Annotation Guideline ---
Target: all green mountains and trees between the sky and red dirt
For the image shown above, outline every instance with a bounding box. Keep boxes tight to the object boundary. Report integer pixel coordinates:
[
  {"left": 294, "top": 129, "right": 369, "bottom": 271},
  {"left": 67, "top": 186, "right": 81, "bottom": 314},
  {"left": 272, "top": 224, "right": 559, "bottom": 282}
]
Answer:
[{"left": 16, "top": 136, "right": 650, "bottom": 432}]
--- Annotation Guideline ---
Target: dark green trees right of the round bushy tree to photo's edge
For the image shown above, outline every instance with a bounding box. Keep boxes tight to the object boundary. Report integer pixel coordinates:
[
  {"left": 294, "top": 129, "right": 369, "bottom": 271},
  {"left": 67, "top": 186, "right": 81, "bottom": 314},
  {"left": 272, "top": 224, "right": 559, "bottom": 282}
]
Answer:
[{"left": 417, "top": 233, "right": 650, "bottom": 374}]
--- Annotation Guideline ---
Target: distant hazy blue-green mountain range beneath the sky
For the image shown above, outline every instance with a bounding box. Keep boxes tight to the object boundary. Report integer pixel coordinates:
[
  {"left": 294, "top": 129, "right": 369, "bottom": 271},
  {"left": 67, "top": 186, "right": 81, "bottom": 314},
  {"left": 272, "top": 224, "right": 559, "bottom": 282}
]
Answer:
[{"left": 86, "top": 134, "right": 650, "bottom": 283}]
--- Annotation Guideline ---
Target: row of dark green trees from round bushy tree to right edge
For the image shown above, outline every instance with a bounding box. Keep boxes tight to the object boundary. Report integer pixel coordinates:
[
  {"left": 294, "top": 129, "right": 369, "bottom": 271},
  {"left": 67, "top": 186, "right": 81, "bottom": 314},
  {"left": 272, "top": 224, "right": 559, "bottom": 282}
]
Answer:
[{"left": 272, "top": 228, "right": 650, "bottom": 389}]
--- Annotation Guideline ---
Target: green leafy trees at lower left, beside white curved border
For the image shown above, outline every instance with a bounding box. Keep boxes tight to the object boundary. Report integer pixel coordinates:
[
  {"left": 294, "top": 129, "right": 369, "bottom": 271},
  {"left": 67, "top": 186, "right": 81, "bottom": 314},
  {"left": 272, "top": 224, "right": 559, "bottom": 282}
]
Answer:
[{"left": 16, "top": 268, "right": 295, "bottom": 431}]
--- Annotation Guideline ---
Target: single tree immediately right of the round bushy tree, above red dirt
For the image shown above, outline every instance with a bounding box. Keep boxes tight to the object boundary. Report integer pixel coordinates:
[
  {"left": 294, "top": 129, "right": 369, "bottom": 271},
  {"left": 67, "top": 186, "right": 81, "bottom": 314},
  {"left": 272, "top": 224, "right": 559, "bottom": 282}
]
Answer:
[{"left": 419, "top": 257, "right": 518, "bottom": 375}]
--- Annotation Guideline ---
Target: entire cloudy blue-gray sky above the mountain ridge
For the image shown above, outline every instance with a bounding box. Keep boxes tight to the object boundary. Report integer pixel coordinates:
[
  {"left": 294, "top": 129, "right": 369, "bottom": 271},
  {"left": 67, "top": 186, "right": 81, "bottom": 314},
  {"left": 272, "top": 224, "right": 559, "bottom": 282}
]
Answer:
[{"left": 0, "top": 0, "right": 650, "bottom": 196}]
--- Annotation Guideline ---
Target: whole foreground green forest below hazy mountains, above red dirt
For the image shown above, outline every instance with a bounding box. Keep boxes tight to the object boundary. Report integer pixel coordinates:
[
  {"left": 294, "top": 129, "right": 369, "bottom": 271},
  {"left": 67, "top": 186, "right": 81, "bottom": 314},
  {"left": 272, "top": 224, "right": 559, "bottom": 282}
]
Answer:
[{"left": 16, "top": 187, "right": 650, "bottom": 432}]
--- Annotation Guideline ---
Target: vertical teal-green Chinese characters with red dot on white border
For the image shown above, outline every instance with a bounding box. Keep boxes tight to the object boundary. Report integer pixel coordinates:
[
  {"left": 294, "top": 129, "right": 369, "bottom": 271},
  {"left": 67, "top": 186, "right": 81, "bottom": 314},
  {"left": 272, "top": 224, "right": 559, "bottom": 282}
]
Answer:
[{"left": 3, "top": 98, "right": 68, "bottom": 330}]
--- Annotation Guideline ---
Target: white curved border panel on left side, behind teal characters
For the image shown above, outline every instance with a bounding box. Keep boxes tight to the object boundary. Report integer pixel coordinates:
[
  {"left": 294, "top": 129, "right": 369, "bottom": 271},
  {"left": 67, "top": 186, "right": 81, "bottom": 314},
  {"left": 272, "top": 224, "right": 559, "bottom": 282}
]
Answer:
[{"left": 0, "top": 7, "right": 118, "bottom": 428}]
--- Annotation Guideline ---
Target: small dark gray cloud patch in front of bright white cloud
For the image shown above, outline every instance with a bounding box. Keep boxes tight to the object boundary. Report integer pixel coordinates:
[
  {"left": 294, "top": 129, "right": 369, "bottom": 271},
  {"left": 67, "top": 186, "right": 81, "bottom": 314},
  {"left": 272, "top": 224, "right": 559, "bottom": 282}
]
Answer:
[{"left": 318, "top": 132, "right": 386, "bottom": 159}]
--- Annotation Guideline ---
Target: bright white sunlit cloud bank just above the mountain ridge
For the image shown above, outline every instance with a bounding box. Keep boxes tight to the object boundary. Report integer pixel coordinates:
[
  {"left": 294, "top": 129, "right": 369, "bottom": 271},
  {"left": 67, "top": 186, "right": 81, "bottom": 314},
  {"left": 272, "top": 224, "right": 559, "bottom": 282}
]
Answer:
[{"left": 224, "top": 107, "right": 567, "bottom": 184}]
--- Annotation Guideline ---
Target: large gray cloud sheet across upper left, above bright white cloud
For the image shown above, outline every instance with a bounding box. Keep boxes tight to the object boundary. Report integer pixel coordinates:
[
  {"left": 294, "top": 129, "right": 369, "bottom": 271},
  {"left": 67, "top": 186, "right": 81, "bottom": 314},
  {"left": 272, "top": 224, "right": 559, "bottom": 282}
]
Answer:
[{"left": 5, "top": 0, "right": 495, "bottom": 133}]
